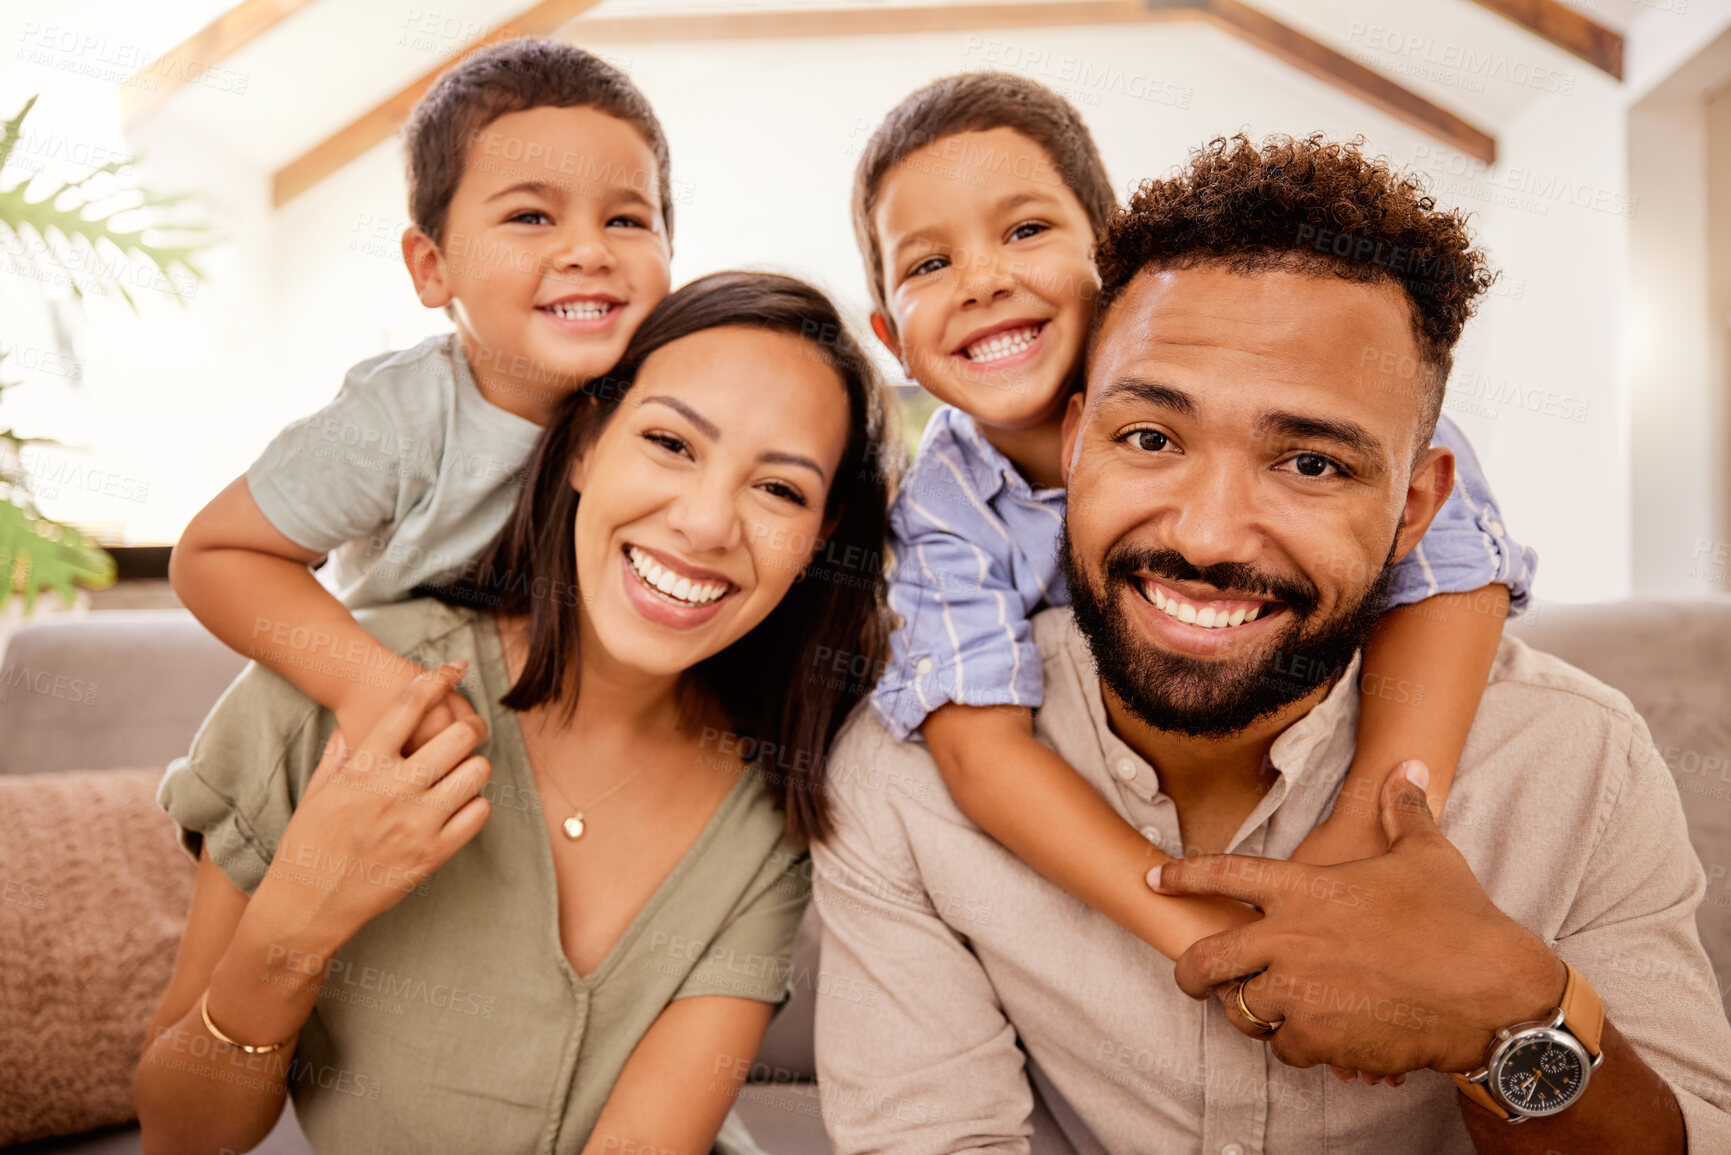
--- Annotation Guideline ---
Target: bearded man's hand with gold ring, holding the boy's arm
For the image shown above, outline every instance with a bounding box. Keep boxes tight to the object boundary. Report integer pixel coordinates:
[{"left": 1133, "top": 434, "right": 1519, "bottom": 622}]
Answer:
[{"left": 1149, "top": 762, "right": 1567, "bottom": 1075}]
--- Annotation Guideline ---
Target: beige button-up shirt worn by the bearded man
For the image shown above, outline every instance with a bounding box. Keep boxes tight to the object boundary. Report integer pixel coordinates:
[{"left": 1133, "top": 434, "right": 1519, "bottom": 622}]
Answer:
[{"left": 814, "top": 610, "right": 1731, "bottom": 1155}]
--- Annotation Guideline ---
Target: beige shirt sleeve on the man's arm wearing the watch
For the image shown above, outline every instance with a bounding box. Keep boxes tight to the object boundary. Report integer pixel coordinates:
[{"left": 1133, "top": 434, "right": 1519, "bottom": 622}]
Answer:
[{"left": 1556, "top": 722, "right": 1731, "bottom": 1152}]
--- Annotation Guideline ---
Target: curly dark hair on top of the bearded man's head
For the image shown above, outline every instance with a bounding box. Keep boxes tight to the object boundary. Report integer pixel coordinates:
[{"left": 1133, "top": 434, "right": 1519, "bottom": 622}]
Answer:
[{"left": 1089, "top": 133, "right": 1496, "bottom": 445}]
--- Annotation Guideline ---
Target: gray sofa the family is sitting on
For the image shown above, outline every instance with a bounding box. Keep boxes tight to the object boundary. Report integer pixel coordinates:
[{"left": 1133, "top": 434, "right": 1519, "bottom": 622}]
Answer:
[{"left": 0, "top": 599, "right": 1731, "bottom": 1155}]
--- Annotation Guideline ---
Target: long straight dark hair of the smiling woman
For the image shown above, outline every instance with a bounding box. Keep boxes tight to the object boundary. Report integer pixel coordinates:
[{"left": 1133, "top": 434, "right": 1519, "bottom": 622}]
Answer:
[{"left": 415, "top": 272, "right": 891, "bottom": 838}]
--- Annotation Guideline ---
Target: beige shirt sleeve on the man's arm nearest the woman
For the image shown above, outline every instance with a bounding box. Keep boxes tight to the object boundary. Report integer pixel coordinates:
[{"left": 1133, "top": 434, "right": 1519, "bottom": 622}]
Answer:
[{"left": 812, "top": 715, "right": 1033, "bottom": 1155}]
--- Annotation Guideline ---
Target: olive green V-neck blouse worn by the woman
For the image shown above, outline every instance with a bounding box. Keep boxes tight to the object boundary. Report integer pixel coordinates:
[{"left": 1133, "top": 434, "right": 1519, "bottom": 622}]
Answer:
[{"left": 158, "top": 599, "right": 810, "bottom": 1155}]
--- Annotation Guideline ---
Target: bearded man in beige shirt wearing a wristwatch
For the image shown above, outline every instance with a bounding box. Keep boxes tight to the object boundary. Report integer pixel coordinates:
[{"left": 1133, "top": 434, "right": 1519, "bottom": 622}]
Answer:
[{"left": 814, "top": 130, "right": 1731, "bottom": 1155}]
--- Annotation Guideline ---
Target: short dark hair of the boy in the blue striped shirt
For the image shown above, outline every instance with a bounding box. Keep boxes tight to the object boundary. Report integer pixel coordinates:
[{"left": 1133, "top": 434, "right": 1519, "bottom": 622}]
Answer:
[{"left": 853, "top": 73, "right": 1118, "bottom": 331}]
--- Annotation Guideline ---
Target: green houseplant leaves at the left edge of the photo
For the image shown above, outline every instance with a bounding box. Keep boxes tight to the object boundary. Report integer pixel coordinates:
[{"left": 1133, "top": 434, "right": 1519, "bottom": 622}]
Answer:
[{"left": 0, "top": 97, "right": 209, "bottom": 613}]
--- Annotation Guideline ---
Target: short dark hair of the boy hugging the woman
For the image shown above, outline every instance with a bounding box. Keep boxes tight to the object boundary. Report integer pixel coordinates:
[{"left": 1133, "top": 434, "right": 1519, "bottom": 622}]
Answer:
[{"left": 403, "top": 36, "right": 673, "bottom": 248}]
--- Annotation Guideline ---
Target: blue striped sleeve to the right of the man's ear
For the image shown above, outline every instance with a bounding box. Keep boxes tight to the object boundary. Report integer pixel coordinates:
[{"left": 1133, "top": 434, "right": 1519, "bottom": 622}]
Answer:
[{"left": 1388, "top": 417, "right": 1539, "bottom": 615}]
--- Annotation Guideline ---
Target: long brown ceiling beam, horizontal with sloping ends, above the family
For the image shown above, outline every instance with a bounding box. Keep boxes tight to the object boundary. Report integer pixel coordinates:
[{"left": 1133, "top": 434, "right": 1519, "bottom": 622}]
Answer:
[{"left": 273, "top": 0, "right": 1496, "bottom": 206}]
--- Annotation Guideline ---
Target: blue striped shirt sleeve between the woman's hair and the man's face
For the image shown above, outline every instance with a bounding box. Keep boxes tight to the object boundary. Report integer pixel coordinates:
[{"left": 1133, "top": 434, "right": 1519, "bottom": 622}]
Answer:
[{"left": 872, "top": 471, "right": 1042, "bottom": 741}]
